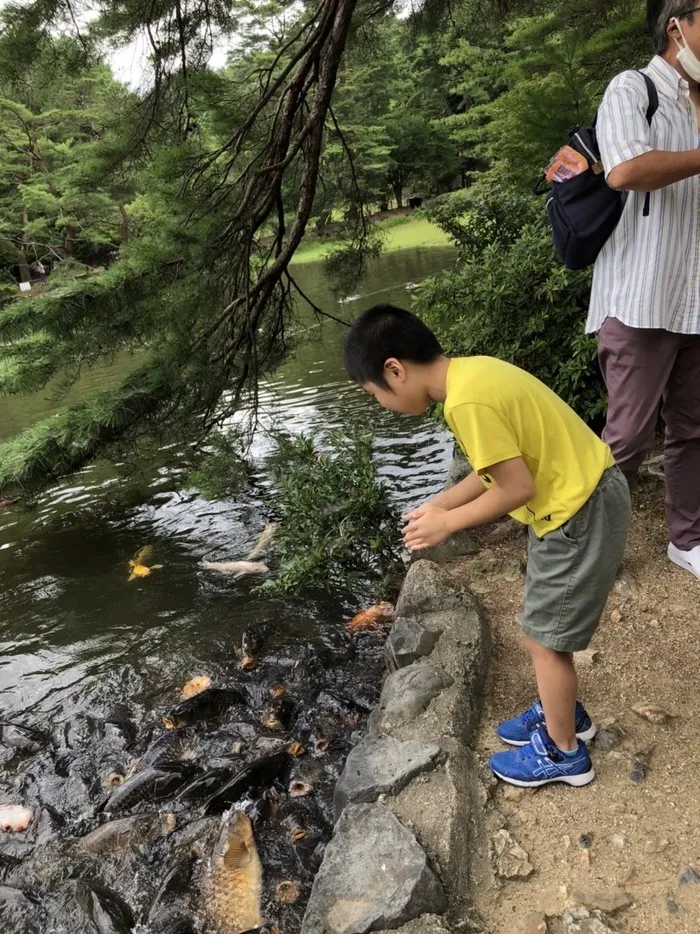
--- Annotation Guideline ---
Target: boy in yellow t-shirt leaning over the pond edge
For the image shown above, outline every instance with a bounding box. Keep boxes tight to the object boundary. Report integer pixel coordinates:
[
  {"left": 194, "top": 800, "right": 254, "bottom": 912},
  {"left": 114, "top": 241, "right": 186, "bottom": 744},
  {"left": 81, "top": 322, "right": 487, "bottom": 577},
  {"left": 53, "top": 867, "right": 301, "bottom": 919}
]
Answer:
[{"left": 344, "top": 305, "right": 631, "bottom": 787}]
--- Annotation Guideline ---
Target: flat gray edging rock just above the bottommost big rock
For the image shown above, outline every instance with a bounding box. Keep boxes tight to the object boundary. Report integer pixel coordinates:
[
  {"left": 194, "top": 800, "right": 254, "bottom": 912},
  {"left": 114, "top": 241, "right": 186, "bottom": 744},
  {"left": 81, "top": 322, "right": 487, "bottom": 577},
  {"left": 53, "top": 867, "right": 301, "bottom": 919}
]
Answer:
[{"left": 333, "top": 735, "right": 440, "bottom": 820}]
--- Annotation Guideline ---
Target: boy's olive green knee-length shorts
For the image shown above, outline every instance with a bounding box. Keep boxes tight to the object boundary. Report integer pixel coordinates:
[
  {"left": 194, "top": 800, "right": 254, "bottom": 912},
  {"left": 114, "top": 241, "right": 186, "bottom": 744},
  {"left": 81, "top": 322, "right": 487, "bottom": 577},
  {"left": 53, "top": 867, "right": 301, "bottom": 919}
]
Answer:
[{"left": 522, "top": 467, "right": 632, "bottom": 652}]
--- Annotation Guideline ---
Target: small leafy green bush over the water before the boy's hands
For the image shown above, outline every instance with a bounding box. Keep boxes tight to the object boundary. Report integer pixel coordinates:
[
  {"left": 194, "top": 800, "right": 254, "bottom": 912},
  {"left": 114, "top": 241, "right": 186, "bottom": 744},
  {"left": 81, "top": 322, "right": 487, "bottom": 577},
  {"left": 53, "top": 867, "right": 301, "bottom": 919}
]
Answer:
[{"left": 262, "top": 429, "right": 401, "bottom": 593}]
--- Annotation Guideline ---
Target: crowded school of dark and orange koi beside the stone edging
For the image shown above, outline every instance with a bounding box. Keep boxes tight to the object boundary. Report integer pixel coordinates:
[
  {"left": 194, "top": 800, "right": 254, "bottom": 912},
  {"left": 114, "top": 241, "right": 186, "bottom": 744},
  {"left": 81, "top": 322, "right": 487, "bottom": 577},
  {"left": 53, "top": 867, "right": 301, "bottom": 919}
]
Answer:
[{"left": 0, "top": 527, "right": 393, "bottom": 934}]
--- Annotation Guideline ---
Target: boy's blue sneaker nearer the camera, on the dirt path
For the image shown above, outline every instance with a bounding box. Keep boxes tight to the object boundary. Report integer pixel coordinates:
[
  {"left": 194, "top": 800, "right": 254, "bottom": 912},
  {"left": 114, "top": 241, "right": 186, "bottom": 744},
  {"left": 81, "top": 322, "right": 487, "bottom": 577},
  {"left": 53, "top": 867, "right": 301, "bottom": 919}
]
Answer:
[{"left": 491, "top": 726, "right": 595, "bottom": 788}]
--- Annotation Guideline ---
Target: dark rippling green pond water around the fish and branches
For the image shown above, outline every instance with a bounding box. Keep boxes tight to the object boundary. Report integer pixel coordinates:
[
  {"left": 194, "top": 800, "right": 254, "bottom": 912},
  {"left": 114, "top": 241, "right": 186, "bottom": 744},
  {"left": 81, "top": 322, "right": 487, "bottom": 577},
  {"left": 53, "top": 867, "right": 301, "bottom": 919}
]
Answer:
[{"left": 0, "top": 248, "right": 454, "bottom": 934}]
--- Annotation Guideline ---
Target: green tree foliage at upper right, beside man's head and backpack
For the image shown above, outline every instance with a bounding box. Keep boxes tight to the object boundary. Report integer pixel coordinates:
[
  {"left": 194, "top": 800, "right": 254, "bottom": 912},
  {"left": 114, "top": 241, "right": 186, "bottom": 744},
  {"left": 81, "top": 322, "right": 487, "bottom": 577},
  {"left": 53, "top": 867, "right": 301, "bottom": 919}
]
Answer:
[{"left": 443, "top": 0, "right": 651, "bottom": 187}]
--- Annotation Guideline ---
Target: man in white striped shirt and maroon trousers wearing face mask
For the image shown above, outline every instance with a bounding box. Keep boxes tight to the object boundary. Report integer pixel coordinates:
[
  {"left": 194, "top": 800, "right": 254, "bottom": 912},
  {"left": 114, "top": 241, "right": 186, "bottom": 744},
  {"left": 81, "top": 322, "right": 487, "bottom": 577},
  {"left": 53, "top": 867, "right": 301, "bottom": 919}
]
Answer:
[{"left": 587, "top": 0, "right": 700, "bottom": 578}]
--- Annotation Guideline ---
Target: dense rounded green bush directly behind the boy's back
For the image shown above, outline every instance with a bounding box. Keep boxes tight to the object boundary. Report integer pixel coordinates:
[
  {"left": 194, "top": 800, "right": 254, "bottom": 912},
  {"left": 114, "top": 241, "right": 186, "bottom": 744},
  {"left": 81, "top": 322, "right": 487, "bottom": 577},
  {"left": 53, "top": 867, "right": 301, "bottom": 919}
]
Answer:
[{"left": 417, "top": 213, "right": 607, "bottom": 422}]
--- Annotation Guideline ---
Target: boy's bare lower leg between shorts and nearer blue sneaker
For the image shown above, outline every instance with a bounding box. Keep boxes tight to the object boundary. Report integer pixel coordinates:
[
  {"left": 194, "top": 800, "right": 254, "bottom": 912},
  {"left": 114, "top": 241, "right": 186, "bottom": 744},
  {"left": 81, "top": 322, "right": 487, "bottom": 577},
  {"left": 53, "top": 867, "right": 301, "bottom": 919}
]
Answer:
[{"left": 523, "top": 635, "right": 578, "bottom": 751}]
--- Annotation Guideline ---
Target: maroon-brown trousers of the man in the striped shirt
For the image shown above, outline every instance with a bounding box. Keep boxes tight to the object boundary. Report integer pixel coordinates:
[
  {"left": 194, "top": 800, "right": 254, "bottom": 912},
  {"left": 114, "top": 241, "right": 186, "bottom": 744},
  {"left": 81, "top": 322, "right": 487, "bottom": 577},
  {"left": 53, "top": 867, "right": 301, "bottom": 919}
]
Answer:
[{"left": 598, "top": 318, "right": 700, "bottom": 551}]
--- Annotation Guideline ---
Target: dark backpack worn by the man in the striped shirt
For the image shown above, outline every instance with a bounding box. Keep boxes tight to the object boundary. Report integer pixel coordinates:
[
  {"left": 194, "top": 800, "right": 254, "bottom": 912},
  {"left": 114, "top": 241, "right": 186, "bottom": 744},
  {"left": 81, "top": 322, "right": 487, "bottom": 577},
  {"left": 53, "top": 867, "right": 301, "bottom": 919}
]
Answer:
[{"left": 535, "top": 71, "right": 659, "bottom": 269}]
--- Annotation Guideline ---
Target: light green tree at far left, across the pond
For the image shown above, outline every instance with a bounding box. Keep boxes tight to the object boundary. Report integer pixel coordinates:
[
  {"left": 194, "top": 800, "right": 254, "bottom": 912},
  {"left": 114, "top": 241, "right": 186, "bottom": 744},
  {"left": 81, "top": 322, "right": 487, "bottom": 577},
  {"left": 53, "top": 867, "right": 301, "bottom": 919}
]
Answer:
[{"left": 0, "top": 41, "right": 133, "bottom": 281}]
